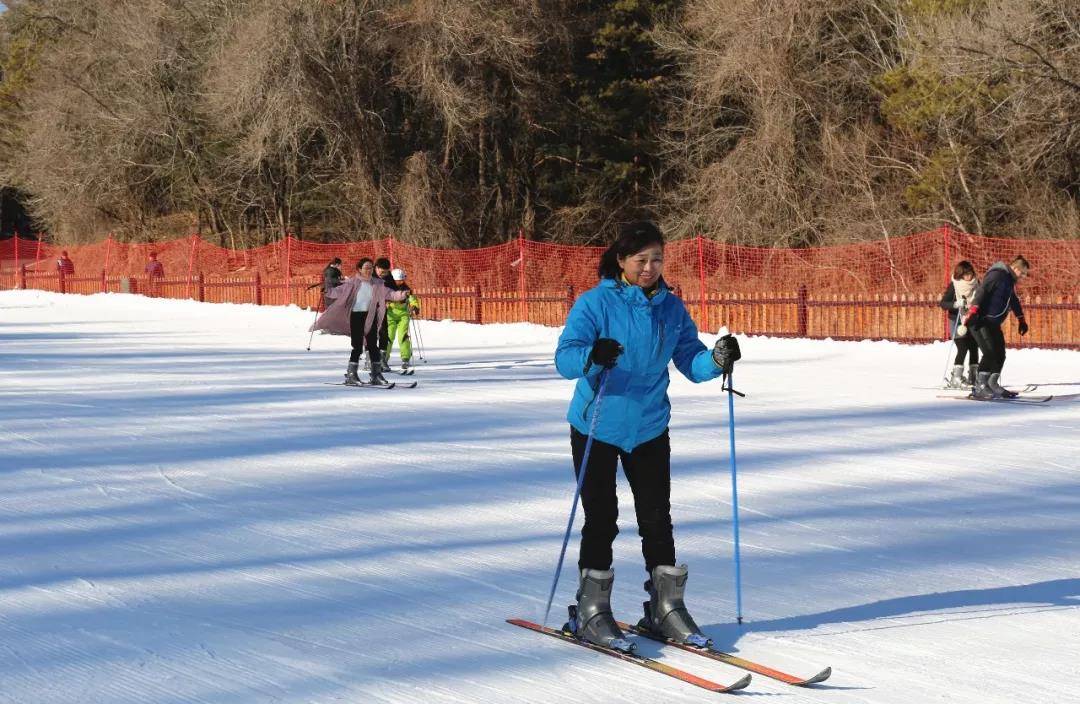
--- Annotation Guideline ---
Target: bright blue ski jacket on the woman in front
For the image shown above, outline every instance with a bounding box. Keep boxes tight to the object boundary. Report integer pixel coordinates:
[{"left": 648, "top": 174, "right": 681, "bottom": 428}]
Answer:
[{"left": 555, "top": 279, "right": 721, "bottom": 452}]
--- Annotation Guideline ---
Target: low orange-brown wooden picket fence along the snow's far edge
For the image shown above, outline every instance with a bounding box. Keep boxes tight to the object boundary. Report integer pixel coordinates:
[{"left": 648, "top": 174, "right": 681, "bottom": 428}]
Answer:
[{"left": 0, "top": 267, "right": 1080, "bottom": 350}]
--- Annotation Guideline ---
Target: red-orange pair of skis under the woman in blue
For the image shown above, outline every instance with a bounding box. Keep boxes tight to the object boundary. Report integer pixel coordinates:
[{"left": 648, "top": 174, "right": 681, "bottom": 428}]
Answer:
[{"left": 507, "top": 619, "right": 833, "bottom": 692}]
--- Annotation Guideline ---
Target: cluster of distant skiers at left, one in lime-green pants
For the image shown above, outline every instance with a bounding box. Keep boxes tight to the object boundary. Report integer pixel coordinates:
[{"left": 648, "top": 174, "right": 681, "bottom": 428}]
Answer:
[{"left": 311, "top": 257, "right": 420, "bottom": 385}]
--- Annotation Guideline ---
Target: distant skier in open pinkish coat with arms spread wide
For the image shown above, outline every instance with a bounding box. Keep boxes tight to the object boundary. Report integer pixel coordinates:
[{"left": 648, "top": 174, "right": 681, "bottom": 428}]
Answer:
[{"left": 311, "top": 257, "right": 408, "bottom": 385}]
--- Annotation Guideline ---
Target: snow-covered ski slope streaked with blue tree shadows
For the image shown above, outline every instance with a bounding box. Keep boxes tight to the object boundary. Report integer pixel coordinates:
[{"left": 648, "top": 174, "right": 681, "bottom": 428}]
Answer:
[{"left": 0, "top": 292, "right": 1080, "bottom": 704}]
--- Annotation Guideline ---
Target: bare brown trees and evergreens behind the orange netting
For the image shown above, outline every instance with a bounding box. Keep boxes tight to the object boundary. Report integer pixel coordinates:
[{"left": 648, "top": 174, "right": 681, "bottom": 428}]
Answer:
[{"left": 0, "top": 0, "right": 1080, "bottom": 247}]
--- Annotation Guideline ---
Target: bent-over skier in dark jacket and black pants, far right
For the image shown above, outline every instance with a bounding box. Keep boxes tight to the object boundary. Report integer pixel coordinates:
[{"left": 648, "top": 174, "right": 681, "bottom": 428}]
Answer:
[{"left": 957, "top": 256, "right": 1030, "bottom": 398}]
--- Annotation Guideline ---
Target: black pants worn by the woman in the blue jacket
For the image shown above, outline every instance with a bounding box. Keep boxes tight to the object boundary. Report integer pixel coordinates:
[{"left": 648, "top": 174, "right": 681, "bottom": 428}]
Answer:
[{"left": 570, "top": 427, "right": 675, "bottom": 573}]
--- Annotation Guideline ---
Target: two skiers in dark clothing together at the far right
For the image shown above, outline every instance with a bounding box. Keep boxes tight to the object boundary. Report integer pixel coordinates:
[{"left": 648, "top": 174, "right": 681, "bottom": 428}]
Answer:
[{"left": 941, "top": 256, "right": 1030, "bottom": 400}]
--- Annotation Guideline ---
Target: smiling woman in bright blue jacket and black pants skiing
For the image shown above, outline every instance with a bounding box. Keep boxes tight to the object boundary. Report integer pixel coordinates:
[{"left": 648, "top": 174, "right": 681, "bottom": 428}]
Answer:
[{"left": 555, "top": 221, "right": 739, "bottom": 648}]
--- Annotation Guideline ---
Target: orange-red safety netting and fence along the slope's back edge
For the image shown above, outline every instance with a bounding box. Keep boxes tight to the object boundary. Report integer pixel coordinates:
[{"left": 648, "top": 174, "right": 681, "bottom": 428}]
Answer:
[{"left": 0, "top": 227, "right": 1080, "bottom": 349}]
